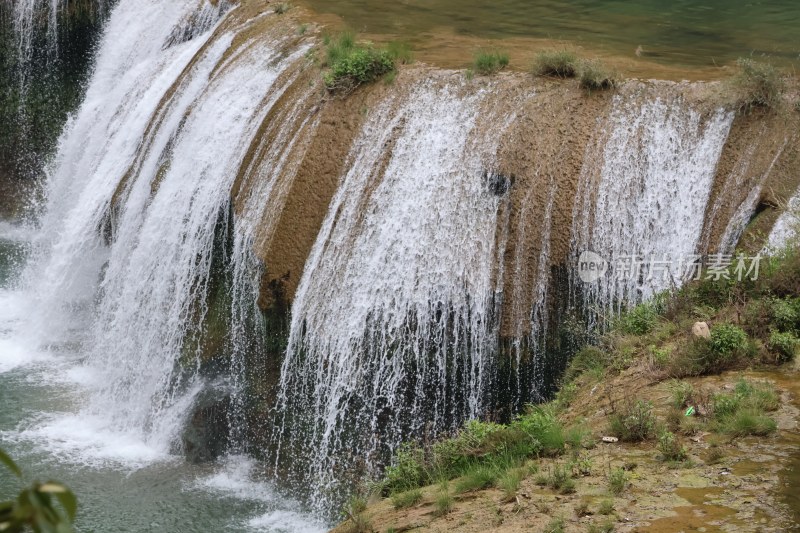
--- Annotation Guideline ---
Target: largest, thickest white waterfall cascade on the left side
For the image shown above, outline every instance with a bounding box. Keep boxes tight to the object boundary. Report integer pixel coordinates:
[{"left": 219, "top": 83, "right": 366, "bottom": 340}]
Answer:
[{"left": 22, "top": 0, "right": 306, "bottom": 453}]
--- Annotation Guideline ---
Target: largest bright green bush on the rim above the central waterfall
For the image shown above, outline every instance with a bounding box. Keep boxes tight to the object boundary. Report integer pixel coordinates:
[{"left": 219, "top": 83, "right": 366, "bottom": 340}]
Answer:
[{"left": 322, "top": 31, "right": 405, "bottom": 93}]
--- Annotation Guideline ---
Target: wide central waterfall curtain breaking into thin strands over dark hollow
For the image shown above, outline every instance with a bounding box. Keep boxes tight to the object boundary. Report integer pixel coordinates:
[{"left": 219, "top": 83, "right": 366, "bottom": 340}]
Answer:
[{"left": 277, "top": 77, "right": 513, "bottom": 511}]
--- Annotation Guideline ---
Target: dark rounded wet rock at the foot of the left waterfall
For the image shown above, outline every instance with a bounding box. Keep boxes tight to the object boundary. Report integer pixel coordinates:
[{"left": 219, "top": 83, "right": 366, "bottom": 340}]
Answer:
[{"left": 181, "top": 391, "right": 231, "bottom": 464}]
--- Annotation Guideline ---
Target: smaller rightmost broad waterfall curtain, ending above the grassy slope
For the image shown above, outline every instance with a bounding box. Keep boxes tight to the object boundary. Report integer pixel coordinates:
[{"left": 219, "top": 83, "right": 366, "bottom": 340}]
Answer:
[{"left": 573, "top": 88, "right": 734, "bottom": 320}]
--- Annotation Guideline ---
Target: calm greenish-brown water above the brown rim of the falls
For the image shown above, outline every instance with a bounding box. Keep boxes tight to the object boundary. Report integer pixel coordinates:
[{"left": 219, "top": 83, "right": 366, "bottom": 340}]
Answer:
[{"left": 298, "top": 0, "right": 800, "bottom": 66}]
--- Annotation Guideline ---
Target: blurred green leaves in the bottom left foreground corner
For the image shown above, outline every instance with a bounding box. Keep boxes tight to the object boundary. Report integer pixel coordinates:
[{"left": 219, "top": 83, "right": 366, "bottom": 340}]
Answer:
[{"left": 0, "top": 450, "right": 78, "bottom": 533}]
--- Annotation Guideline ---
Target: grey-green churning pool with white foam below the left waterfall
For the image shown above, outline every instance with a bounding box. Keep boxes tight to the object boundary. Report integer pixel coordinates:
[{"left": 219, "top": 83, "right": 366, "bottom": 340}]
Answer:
[{"left": 0, "top": 221, "right": 325, "bottom": 533}]
